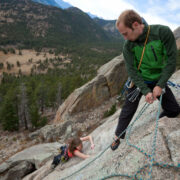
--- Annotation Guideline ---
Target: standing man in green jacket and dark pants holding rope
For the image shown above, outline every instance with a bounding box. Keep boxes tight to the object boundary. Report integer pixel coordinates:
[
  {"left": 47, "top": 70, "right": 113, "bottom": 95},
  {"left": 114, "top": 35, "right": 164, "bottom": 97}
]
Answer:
[{"left": 111, "top": 10, "right": 180, "bottom": 150}]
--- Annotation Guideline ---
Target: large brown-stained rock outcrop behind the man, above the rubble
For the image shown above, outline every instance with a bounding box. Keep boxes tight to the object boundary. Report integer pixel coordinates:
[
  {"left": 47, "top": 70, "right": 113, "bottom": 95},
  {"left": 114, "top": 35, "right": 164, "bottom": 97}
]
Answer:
[{"left": 54, "top": 55, "right": 127, "bottom": 123}]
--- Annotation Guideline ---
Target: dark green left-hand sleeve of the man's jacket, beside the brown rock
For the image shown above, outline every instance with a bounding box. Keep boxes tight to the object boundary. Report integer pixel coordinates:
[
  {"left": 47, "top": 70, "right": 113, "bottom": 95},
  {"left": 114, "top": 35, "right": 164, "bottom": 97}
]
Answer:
[{"left": 123, "top": 42, "right": 151, "bottom": 95}]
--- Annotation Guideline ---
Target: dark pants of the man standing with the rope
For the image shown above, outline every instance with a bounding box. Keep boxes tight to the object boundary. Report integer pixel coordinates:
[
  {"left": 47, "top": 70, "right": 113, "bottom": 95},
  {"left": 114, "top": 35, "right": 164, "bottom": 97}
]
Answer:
[{"left": 115, "top": 84, "right": 180, "bottom": 139}]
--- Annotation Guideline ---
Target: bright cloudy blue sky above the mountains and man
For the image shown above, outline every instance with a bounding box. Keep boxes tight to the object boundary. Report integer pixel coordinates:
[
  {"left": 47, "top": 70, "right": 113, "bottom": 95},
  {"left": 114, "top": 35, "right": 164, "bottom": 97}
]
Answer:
[{"left": 64, "top": 0, "right": 180, "bottom": 31}]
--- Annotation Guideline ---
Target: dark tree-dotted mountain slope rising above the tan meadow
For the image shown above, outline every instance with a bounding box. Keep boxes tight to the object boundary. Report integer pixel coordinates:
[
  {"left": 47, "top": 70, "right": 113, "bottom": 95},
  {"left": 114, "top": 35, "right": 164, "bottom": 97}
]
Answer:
[{"left": 0, "top": 0, "right": 110, "bottom": 47}]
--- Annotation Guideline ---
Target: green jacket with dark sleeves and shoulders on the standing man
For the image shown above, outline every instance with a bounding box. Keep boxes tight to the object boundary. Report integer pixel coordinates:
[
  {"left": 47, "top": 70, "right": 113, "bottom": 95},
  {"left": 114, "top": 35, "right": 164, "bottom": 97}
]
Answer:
[{"left": 123, "top": 25, "right": 177, "bottom": 95}]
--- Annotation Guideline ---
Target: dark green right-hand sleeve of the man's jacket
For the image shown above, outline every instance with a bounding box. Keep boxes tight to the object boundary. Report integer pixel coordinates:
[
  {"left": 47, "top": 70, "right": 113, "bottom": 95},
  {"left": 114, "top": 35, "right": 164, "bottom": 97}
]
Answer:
[{"left": 157, "top": 26, "right": 177, "bottom": 88}]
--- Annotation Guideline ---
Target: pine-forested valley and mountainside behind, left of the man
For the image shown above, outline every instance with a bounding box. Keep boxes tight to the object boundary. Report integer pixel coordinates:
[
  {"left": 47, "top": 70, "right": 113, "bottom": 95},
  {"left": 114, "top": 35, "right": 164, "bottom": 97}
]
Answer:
[{"left": 0, "top": 0, "right": 122, "bottom": 131}]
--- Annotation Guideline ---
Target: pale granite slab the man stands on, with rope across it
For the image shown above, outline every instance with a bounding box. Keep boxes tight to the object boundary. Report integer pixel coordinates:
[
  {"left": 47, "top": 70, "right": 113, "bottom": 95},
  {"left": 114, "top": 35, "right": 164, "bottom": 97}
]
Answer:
[{"left": 25, "top": 71, "right": 180, "bottom": 180}]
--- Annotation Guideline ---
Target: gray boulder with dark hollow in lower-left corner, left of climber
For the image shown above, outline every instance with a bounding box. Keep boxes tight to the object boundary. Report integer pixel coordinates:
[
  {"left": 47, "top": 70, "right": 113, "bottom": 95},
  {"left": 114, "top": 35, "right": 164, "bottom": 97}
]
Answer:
[{"left": 0, "top": 143, "right": 61, "bottom": 180}]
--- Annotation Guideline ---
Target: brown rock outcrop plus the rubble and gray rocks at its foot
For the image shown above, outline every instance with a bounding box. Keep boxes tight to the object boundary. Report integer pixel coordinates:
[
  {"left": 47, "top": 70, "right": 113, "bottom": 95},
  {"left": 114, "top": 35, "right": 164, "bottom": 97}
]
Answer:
[{"left": 25, "top": 55, "right": 127, "bottom": 142}]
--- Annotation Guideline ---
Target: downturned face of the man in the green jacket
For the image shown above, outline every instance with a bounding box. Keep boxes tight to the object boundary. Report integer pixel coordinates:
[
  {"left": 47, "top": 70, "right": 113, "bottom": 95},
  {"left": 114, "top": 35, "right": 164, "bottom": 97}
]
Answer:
[{"left": 118, "top": 23, "right": 140, "bottom": 41}]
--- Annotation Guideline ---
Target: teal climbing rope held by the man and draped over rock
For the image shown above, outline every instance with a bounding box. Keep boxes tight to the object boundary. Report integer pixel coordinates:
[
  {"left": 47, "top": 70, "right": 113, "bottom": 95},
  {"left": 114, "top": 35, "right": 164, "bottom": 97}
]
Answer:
[{"left": 60, "top": 81, "right": 180, "bottom": 180}]
